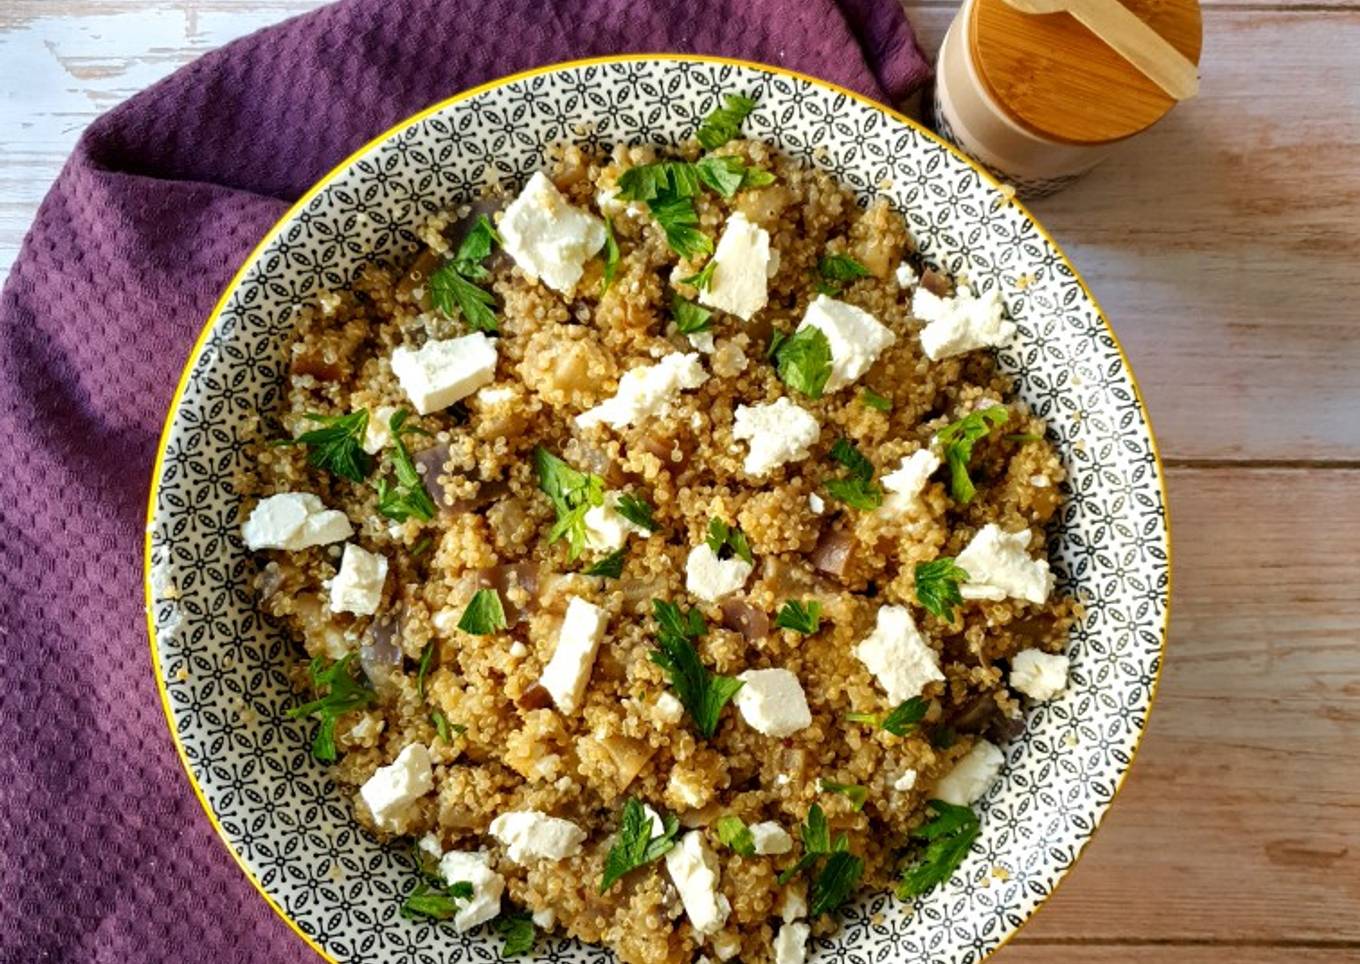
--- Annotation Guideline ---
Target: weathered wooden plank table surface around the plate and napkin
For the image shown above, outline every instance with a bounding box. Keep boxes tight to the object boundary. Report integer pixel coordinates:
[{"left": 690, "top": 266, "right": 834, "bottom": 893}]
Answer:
[{"left": 0, "top": 0, "right": 1360, "bottom": 964}]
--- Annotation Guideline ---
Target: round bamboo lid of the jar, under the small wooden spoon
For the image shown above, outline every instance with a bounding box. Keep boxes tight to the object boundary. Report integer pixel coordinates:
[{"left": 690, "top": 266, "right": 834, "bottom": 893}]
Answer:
[{"left": 968, "top": 0, "right": 1202, "bottom": 144}]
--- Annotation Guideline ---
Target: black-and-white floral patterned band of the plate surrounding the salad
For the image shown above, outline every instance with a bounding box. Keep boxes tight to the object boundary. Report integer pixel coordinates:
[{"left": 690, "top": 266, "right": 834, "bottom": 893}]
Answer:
[{"left": 148, "top": 57, "right": 1168, "bottom": 964}]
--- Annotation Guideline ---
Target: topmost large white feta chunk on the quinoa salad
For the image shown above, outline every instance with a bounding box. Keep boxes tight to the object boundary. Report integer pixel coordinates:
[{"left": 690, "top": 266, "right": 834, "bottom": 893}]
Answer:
[{"left": 499, "top": 171, "right": 605, "bottom": 295}]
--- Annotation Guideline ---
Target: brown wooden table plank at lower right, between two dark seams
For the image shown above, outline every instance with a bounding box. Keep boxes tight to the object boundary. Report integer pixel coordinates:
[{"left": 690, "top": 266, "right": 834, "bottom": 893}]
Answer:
[{"left": 1000, "top": 469, "right": 1360, "bottom": 946}]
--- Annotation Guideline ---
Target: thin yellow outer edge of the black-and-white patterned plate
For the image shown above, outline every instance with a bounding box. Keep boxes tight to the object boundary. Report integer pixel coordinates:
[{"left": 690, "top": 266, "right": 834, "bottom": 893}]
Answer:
[{"left": 143, "top": 53, "right": 1175, "bottom": 964}]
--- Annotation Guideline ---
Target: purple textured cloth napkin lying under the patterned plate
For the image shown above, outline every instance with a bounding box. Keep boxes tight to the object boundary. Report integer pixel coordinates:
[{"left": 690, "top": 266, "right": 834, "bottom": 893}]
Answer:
[{"left": 0, "top": 0, "right": 929, "bottom": 964}]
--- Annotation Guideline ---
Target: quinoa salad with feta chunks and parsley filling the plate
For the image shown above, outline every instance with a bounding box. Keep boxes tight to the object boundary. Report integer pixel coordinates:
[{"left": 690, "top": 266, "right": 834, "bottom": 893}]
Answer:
[{"left": 242, "top": 95, "right": 1080, "bottom": 964}]
